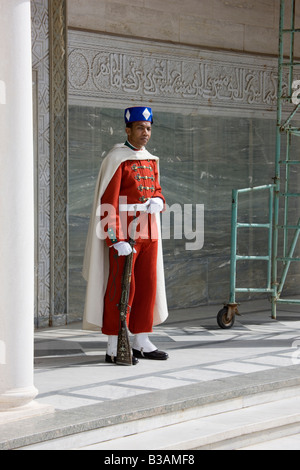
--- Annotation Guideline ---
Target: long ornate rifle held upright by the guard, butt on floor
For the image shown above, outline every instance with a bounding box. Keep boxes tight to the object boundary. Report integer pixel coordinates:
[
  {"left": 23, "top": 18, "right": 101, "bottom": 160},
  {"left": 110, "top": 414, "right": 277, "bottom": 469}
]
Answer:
[{"left": 116, "top": 211, "right": 137, "bottom": 366}]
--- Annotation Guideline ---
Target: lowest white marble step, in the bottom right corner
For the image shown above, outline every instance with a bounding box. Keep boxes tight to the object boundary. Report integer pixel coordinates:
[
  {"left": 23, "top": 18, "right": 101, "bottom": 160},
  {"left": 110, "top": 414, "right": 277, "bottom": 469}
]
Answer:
[{"left": 82, "top": 397, "right": 300, "bottom": 451}]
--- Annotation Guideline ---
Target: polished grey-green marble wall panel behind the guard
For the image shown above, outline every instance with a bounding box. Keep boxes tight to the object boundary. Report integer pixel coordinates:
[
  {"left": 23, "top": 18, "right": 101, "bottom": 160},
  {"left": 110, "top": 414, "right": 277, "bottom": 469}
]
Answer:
[{"left": 69, "top": 105, "right": 299, "bottom": 318}]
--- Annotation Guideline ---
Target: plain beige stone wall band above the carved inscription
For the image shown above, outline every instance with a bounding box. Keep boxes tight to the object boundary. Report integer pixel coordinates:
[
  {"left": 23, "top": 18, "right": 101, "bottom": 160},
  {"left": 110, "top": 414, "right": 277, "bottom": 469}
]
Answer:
[{"left": 68, "top": 0, "right": 300, "bottom": 56}]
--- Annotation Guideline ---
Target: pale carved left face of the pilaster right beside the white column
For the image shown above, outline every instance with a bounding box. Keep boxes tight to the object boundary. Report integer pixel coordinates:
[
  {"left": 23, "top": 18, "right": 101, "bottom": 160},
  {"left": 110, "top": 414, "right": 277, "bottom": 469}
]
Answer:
[{"left": 31, "top": 0, "right": 51, "bottom": 326}]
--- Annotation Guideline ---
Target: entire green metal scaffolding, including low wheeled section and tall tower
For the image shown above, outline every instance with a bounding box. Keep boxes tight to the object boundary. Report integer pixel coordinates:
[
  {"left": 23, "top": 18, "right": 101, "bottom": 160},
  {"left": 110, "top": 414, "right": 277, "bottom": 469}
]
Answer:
[{"left": 218, "top": 0, "right": 300, "bottom": 328}]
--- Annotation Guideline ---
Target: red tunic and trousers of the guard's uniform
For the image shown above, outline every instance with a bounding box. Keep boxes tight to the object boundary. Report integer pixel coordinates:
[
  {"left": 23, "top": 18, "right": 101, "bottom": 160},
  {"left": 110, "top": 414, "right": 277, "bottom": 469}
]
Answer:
[{"left": 101, "top": 152, "right": 165, "bottom": 335}]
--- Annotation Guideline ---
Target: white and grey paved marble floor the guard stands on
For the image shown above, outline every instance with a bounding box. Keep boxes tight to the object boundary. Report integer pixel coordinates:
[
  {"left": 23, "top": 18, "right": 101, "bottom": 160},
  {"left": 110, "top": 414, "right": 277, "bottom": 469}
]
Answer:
[{"left": 35, "top": 301, "right": 300, "bottom": 410}]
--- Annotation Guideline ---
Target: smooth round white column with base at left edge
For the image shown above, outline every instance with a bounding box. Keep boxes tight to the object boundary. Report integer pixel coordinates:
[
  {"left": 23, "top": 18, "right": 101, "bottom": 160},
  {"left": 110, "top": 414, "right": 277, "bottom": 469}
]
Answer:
[{"left": 0, "top": 0, "right": 37, "bottom": 411}]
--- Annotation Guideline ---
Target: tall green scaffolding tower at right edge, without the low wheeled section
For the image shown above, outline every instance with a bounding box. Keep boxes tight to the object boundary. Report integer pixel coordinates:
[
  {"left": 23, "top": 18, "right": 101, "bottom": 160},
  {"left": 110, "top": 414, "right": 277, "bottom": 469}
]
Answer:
[{"left": 272, "top": 0, "right": 300, "bottom": 319}]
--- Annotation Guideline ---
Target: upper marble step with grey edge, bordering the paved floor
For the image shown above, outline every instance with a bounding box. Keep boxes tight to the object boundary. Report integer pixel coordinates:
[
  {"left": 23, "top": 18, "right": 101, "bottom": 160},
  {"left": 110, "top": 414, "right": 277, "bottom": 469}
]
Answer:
[{"left": 0, "top": 366, "right": 300, "bottom": 450}]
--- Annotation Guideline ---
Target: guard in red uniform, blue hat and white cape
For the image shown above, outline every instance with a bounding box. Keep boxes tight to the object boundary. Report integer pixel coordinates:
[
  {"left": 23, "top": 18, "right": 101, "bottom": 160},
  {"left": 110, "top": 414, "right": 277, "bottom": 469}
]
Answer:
[{"left": 83, "top": 107, "right": 168, "bottom": 365}]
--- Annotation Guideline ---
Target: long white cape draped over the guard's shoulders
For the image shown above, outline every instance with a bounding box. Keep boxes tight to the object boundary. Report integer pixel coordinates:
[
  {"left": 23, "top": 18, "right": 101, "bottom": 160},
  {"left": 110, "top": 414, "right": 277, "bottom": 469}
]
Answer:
[{"left": 82, "top": 144, "right": 168, "bottom": 331}]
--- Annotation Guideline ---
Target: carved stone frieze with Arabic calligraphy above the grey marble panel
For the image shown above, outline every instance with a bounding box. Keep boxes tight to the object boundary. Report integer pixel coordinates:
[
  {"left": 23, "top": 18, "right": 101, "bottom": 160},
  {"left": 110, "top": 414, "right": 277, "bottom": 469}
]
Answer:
[{"left": 69, "top": 31, "right": 277, "bottom": 111}]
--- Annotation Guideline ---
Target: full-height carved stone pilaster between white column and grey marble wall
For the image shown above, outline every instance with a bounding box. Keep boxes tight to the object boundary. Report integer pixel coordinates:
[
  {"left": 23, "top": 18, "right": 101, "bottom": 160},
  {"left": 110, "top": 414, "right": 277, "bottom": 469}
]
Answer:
[{"left": 31, "top": 0, "right": 68, "bottom": 328}]
